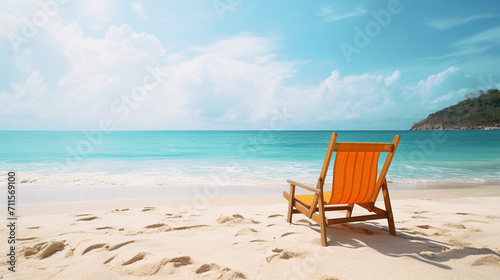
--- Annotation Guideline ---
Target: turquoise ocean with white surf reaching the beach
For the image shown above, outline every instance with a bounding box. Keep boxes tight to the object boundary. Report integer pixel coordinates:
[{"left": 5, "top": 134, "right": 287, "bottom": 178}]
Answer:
[{"left": 0, "top": 130, "right": 500, "bottom": 186}]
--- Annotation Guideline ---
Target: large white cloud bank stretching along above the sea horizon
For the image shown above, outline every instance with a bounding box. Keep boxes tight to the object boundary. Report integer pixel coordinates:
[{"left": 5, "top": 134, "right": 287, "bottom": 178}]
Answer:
[{"left": 0, "top": 12, "right": 476, "bottom": 129}]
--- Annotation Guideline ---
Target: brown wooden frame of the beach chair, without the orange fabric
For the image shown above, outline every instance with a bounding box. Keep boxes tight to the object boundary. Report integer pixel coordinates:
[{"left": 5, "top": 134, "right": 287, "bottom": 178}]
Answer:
[{"left": 283, "top": 133, "right": 401, "bottom": 246}]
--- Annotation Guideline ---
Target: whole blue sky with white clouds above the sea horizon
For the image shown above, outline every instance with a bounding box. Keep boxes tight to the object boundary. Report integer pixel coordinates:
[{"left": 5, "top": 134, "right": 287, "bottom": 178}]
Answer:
[{"left": 0, "top": 0, "right": 500, "bottom": 130}]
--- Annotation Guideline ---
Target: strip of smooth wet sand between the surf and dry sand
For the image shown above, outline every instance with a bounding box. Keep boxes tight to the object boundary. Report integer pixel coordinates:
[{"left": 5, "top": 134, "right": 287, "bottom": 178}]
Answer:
[{"left": 0, "top": 180, "right": 500, "bottom": 206}]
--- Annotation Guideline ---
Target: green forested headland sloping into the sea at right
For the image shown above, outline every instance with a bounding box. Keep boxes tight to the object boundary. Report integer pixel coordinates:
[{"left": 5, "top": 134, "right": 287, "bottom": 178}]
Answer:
[{"left": 410, "top": 88, "right": 500, "bottom": 130}]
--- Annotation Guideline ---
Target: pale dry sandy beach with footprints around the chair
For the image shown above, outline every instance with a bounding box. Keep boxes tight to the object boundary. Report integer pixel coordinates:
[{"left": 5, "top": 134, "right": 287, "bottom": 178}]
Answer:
[{"left": 0, "top": 185, "right": 500, "bottom": 279}]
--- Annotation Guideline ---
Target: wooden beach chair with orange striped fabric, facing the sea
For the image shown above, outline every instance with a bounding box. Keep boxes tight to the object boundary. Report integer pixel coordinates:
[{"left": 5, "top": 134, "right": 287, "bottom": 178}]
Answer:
[{"left": 283, "top": 133, "right": 401, "bottom": 246}]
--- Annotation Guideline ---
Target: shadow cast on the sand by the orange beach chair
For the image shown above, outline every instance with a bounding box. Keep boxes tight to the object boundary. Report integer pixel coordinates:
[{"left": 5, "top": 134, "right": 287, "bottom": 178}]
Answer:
[{"left": 296, "top": 222, "right": 500, "bottom": 270}]
